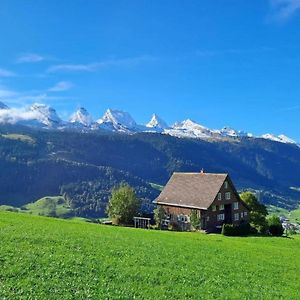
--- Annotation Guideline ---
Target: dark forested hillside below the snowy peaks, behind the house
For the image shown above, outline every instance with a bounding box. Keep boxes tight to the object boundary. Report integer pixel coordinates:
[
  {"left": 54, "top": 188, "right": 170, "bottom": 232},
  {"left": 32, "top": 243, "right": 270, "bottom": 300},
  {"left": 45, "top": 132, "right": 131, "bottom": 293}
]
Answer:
[{"left": 0, "top": 126, "right": 300, "bottom": 215}]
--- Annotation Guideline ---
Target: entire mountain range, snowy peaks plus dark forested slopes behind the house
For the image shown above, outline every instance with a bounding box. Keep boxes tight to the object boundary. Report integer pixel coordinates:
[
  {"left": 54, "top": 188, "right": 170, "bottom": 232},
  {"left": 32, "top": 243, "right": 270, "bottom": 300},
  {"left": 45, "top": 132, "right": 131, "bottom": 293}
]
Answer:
[{"left": 0, "top": 103, "right": 300, "bottom": 217}]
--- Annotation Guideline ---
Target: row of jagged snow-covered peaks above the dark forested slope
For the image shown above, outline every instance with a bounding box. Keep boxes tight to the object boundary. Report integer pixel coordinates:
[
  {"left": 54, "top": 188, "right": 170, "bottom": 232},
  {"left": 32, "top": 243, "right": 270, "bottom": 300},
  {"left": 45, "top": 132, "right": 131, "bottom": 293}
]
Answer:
[{"left": 0, "top": 102, "right": 298, "bottom": 145}]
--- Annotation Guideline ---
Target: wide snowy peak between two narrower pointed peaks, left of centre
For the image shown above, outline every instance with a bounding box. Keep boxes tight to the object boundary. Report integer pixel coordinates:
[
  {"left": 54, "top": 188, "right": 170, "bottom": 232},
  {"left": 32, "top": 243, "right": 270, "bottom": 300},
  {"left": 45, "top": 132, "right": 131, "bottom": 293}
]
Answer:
[{"left": 97, "top": 109, "right": 138, "bottom": 133}]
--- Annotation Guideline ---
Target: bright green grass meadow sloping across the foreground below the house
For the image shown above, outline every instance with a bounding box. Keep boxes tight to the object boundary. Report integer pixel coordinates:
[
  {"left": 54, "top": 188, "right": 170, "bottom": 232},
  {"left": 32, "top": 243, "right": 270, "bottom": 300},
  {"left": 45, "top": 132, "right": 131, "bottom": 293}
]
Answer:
[{"left": 0, "top": 212, "right": 300, "bottom": 299}]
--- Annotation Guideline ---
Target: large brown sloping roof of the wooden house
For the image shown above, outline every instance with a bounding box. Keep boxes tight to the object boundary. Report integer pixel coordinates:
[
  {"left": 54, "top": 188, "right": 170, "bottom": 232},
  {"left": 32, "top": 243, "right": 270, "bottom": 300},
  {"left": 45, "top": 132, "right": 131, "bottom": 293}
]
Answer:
[{"left": 154, "top": 173, "right": 228, "bottom": 209}]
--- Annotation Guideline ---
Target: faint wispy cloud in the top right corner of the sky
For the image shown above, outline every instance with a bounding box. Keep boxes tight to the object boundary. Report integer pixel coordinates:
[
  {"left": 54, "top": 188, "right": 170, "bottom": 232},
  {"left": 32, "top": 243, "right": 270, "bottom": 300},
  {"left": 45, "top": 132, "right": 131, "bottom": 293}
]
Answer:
[{"left": 270, "top": 0, "right": 300, "bottom": 21}]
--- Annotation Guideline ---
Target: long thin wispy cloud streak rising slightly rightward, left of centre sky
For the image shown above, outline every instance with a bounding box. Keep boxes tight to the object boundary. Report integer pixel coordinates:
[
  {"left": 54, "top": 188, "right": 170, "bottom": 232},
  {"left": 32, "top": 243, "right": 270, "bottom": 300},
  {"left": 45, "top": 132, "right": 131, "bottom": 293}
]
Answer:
[{"left": 47, "top": 55, "right": 156, "bottom": 73}]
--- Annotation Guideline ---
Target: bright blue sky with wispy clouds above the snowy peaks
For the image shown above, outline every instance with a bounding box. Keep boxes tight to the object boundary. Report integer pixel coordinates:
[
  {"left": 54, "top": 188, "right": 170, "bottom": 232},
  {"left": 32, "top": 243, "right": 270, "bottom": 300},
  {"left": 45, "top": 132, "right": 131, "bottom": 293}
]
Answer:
[{"left": 0, "top": 0, "right": 300, "bottom": 141}]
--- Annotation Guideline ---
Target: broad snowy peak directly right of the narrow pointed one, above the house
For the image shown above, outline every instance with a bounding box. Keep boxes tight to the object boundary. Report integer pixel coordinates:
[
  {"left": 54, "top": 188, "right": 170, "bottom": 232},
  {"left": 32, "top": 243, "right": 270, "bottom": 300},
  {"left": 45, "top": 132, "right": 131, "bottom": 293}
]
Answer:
[{"left": 164, "top": 119, "right": 217, "bottom": 138}]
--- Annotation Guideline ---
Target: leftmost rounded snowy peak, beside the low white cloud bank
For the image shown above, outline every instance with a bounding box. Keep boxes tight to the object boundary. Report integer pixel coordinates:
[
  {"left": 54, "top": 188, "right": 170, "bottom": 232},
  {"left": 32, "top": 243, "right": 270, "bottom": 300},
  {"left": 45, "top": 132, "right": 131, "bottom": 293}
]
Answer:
[{"left": 29, "top": 103, "right": 62, "bottom": 128}]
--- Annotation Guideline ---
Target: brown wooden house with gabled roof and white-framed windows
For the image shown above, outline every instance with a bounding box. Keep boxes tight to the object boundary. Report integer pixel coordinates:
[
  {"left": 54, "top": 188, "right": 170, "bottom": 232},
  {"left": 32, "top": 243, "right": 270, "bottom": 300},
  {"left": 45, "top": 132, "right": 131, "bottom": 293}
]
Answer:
[{"left": 154, "top": 170, "right": 249, "bottom": 232}]
